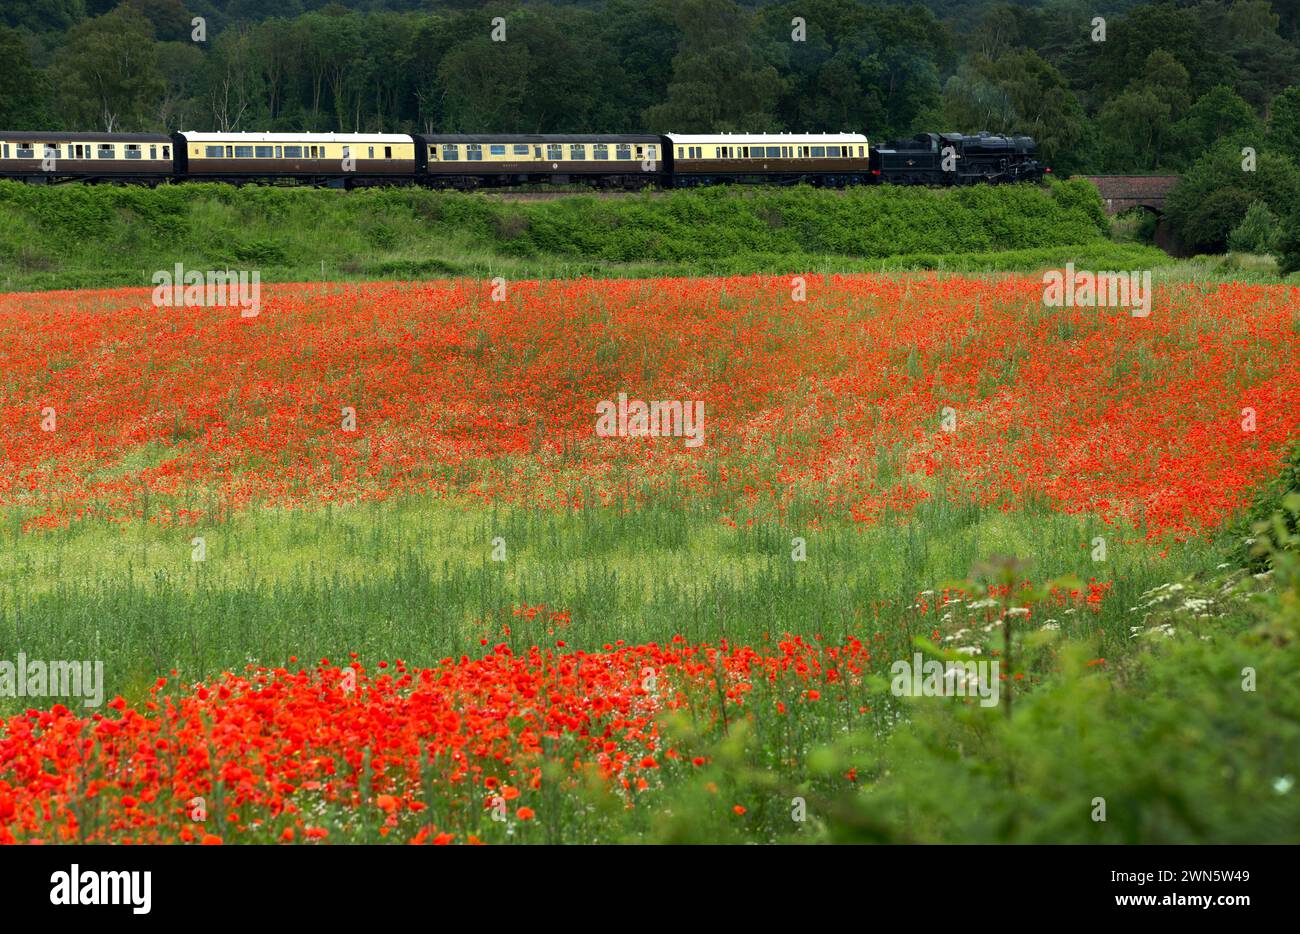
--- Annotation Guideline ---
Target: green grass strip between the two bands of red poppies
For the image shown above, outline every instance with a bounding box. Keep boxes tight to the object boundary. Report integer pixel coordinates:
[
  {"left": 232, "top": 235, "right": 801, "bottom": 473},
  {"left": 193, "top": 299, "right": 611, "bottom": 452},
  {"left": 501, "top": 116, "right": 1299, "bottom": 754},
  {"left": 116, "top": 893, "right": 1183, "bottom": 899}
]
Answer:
[{"left": 0, "top": 489, "right": 1218, "bottom": 709}]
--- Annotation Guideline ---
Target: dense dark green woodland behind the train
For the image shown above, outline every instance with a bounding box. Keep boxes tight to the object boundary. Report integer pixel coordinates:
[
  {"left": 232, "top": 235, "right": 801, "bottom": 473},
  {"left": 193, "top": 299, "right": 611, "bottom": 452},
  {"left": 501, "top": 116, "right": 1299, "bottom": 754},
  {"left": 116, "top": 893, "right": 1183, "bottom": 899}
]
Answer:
[{"left": 0, "top": 0, "right": 1300, "bottom": 178}]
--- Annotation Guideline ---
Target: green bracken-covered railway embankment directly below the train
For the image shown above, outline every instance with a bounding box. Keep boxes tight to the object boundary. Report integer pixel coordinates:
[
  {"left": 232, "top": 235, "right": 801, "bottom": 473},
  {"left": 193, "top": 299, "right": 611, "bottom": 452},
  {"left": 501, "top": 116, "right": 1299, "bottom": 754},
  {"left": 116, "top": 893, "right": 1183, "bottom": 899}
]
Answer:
[{"left": 0, "top": 181, "right": 1112, "bottom": 289}]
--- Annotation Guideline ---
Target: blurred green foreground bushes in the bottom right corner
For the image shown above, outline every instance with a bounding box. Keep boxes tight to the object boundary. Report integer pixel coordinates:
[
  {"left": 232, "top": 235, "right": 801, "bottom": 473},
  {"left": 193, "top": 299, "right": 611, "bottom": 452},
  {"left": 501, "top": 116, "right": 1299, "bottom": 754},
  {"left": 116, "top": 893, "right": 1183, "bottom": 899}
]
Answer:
[{"left": 659, "top": 496, "right": 1300, "bottom": 844}]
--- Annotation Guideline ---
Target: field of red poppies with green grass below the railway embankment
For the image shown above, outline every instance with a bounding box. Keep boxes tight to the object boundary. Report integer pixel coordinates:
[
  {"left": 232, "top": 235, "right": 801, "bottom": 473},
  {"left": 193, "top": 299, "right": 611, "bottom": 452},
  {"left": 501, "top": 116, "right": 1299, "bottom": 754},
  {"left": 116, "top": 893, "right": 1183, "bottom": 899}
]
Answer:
[{"left": 0, "top": 274, "right": 1300, "bottom": 844}]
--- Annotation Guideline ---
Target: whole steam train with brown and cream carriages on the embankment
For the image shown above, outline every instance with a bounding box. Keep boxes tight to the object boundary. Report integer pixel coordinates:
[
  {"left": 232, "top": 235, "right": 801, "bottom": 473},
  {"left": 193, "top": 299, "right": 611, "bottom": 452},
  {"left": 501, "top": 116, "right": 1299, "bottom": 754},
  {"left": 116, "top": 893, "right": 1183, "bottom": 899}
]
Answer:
[{"left": 0, "top": 130, "right": 1052, "bottom": 190}]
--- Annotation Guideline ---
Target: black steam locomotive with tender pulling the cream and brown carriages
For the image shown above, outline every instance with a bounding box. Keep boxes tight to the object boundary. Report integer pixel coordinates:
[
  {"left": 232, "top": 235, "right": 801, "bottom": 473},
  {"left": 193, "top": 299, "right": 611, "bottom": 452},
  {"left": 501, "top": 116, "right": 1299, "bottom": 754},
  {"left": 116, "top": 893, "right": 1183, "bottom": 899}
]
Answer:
[{"left": 871, "top": 133, "right": 1052, "bottom": 185}]
